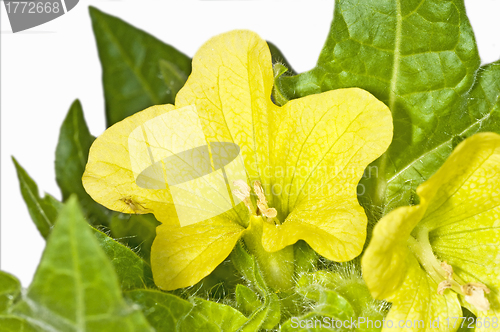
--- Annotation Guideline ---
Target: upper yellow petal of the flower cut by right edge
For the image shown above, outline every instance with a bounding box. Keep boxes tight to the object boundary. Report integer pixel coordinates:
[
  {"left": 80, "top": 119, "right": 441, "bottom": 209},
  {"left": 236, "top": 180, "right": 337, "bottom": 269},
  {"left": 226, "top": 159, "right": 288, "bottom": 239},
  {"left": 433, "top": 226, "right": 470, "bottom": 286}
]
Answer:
[{"left": 417, "top": 133, "right": 500, "bottom": 233}]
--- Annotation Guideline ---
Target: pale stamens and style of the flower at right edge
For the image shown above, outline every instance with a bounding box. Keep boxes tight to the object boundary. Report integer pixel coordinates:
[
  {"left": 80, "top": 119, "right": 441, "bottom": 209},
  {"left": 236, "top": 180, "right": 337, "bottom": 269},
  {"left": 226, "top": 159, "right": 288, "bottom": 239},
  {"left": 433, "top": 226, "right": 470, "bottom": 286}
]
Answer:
[{"left": 407, "top": 228, "right": 490, "bottom": 311}]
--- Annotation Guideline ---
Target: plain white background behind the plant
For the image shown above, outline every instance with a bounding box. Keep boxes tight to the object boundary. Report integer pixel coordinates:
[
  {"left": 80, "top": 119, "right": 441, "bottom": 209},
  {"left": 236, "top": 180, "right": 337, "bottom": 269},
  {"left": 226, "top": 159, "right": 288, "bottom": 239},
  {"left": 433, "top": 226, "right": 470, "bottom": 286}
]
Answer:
[{"left": 0, "top": 0, "right": 500, "bottom": 287}]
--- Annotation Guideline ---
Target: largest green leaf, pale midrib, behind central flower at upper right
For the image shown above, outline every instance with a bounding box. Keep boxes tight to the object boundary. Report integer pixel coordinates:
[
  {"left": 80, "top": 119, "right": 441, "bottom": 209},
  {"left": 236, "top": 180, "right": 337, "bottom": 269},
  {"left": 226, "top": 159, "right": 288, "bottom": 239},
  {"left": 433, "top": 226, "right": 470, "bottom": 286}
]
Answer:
[{"left": 278, "top": 0, "right": 485, "bottom": 218}]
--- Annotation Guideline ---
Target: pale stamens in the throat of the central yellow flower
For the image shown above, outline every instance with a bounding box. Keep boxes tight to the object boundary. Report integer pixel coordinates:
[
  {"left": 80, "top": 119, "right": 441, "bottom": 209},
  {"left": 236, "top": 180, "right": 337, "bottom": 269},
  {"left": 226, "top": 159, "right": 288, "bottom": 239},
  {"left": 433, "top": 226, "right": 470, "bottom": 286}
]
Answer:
[{"left": 233, "top": 180, "right": 280, "bottom": 225}]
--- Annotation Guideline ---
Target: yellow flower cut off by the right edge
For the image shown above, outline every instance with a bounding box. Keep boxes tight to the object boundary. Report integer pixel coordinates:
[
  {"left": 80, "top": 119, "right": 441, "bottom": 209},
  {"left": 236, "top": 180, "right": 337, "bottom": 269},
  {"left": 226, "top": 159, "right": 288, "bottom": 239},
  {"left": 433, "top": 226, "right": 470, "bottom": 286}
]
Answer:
[{"left": 362, "top": 133, "right": 500, "bottom": 331}]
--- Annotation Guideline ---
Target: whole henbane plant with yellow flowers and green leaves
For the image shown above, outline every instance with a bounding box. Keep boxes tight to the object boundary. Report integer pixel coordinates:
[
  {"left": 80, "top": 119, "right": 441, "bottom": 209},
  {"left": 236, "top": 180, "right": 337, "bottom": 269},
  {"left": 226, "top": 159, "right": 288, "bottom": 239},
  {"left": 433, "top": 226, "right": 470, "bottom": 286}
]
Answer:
[{"left": 4, "top": 0, "right": 500, "bottom": 331}]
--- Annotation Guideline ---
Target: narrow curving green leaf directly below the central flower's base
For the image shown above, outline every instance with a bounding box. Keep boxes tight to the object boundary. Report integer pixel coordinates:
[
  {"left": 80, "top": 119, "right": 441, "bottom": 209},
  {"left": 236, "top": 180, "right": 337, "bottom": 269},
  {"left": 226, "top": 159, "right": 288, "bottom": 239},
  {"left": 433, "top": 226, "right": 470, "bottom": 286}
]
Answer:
[{"left": 231, "top": 241, "right": 281, "bottom": 332}]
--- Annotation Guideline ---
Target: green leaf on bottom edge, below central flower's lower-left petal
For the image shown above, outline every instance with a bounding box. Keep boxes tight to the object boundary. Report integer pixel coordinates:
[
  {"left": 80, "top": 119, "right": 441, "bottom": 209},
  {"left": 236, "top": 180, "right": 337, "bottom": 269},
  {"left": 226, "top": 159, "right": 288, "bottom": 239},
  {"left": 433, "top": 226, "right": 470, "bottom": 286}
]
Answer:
[{"left": 126, "top": 290, "right": 246, "bottom": 332}]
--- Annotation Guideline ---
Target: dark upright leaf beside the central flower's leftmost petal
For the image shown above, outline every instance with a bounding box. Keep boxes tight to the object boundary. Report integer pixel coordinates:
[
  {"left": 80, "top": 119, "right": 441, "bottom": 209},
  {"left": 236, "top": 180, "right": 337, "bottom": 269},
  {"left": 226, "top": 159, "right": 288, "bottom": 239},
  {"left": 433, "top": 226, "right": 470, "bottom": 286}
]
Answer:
[{"left": 56, "top": 100, "right": 109, "bottom": 225}]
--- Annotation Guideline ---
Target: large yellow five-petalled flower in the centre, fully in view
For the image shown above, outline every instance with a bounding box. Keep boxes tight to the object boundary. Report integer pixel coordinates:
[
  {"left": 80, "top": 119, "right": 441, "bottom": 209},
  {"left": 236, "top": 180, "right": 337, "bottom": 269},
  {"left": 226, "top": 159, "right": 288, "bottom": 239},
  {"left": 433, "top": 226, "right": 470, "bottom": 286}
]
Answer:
[{"left": 83, "top": 31, "right": 392, "bottom": 290}]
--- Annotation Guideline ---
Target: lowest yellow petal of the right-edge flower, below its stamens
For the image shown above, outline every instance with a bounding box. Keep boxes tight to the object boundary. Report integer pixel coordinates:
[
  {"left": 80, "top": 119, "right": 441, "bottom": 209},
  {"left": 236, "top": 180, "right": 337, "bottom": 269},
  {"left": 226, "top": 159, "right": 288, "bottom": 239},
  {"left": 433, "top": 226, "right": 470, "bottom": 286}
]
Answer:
[{"left": 382, "top": 257, "right": 462, "bottom": 331}]
